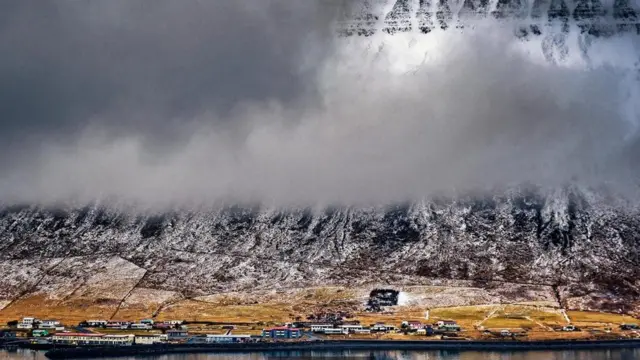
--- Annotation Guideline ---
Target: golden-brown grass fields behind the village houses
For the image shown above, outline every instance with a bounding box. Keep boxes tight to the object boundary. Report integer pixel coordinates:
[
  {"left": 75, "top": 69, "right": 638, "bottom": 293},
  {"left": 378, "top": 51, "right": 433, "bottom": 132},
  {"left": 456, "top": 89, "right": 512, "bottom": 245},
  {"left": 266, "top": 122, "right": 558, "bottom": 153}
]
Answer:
[{"left": 0, "top": 286, "right": 639, "bottom": 339}]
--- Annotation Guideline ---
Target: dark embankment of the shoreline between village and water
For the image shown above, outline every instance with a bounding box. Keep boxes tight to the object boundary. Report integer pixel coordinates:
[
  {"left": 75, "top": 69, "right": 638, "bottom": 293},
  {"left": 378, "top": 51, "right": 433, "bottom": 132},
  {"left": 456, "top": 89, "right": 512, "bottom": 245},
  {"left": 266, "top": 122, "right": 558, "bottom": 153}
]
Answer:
[{"left": 45, "top": 339, "right": 640, "bottom": 359}]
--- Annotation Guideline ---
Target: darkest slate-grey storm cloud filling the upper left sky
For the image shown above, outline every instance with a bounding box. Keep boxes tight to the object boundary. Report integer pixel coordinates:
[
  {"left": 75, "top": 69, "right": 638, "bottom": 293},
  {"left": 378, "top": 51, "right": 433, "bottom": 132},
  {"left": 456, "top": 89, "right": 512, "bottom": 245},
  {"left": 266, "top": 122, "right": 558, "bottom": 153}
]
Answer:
[{"left": 0, "top": 0, "right": 340, "bottom": 158}]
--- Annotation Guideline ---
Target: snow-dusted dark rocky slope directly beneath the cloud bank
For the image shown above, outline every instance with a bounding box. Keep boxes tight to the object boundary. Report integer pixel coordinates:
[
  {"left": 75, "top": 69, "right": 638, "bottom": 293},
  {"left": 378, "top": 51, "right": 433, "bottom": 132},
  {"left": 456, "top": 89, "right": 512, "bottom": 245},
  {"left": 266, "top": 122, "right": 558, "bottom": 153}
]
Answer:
[{"left": 0, "top": 184, "right": 640, "bottom": 311}]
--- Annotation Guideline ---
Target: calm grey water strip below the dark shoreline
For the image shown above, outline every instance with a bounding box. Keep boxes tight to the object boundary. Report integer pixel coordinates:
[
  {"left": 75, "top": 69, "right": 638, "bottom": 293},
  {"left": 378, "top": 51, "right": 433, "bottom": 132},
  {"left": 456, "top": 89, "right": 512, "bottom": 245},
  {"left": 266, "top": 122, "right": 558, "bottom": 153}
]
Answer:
[{"left": 0, "top": 349, "right": 640, "bottom": 360}]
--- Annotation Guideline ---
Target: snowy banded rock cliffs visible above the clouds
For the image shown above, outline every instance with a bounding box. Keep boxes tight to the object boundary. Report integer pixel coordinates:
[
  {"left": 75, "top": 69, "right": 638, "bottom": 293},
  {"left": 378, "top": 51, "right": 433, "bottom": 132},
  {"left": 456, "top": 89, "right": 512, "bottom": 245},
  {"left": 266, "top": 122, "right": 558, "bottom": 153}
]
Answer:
[{"left": 340, "top": 0, "right": 640, "bottom": 36}]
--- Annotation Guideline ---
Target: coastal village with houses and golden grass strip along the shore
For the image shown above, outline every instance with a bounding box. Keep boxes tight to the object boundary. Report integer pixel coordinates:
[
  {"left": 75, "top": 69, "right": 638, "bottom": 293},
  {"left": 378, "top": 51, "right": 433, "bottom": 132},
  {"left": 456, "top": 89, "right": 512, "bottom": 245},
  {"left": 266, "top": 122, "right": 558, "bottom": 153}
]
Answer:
[{"left": 0, "top": 289, "right": 640, "bottom": 348}]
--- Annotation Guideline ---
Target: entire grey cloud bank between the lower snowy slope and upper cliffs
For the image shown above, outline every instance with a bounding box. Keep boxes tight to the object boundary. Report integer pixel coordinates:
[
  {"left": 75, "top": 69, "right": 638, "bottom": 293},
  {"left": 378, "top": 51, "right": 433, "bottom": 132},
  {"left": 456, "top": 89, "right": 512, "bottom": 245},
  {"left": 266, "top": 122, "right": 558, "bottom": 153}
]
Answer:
[{"left": 0, "top": 1, "right": 638, "bottom": 205}]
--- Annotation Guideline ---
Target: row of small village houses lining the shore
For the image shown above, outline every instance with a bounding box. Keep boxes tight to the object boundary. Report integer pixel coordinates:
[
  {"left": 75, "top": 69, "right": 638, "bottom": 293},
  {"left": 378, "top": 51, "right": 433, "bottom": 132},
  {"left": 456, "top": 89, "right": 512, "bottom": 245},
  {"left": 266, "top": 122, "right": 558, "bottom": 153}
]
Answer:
[{"left": 0, "top": 317, "right": 640, "bottom": 348}]
